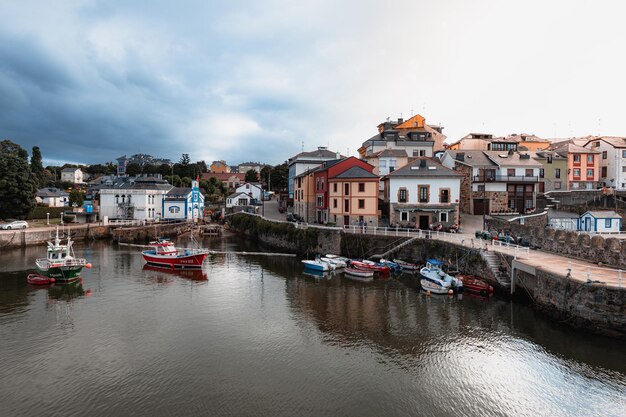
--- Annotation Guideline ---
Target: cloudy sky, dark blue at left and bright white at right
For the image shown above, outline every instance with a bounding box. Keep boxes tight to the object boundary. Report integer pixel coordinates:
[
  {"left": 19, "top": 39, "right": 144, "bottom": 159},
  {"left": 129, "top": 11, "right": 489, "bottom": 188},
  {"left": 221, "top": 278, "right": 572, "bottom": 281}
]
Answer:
[{"left": 0, "top": 0, "right": 626, "bottom": 164}]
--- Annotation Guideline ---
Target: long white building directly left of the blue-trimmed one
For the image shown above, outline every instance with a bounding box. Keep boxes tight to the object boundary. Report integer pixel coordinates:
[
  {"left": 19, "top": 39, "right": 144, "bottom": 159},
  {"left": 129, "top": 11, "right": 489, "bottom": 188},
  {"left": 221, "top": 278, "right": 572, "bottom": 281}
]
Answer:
[{"left": 100, "top": 177, "right": 172, "bottom": 220}]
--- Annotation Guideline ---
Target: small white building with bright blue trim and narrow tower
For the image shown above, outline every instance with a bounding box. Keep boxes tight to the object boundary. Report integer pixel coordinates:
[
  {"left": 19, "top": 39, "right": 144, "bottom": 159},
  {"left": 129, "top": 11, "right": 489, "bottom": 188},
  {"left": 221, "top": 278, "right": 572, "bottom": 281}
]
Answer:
[{"left": 161, "top": 180, "right": 204, "bottom": 222}]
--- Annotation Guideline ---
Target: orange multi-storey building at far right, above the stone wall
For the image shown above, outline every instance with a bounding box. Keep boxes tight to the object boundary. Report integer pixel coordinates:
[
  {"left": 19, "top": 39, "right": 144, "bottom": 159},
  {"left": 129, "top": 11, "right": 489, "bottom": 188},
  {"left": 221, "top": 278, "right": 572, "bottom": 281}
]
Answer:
[{"left": 550, "top": 140, "right": 602, "bottom": 190}]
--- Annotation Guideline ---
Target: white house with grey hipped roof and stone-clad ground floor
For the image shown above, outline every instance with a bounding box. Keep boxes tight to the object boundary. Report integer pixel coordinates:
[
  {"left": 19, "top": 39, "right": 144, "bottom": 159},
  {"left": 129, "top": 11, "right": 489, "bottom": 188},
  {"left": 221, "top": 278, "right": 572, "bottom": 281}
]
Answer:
[{"left": 383, "top": 157, "right": 462, "bottom": 230}]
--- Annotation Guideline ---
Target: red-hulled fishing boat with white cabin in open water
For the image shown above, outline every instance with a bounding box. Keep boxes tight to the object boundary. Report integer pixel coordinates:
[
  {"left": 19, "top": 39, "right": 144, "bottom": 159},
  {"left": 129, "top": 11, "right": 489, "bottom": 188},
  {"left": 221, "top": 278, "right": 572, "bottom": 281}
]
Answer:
[{"left": 141, "top": 239, "right": 209, "bottom": 269}]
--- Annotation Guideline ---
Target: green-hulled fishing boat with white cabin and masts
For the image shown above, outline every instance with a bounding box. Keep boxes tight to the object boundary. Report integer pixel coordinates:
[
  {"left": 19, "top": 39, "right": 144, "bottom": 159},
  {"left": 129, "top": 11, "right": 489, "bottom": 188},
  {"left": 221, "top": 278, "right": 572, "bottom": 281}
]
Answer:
[{"left": 35, "top": 229, "right": 91, "bottom": 282}]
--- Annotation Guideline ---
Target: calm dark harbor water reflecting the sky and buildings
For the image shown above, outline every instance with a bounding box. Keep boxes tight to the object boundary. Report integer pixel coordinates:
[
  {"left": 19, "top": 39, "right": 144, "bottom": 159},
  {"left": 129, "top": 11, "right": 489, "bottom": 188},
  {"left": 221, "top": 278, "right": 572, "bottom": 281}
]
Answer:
[{"left": 0, "top": 237, "right": 626, "bottom": 417}]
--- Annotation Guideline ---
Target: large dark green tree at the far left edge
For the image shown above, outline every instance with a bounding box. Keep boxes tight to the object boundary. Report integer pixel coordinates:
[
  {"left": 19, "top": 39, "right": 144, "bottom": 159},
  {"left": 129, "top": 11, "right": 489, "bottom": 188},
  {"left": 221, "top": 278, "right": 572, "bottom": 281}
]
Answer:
[{"left": 0, "top": 140, "right": 38, "bottom": 219}]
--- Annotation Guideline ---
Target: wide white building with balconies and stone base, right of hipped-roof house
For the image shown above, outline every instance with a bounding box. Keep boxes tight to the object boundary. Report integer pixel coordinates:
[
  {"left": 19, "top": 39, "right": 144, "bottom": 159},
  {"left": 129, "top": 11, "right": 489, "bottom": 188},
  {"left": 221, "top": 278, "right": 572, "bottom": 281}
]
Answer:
[{"left": 442, "top": 150, "right": 542, "bottom": 214}]
